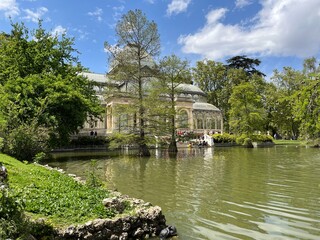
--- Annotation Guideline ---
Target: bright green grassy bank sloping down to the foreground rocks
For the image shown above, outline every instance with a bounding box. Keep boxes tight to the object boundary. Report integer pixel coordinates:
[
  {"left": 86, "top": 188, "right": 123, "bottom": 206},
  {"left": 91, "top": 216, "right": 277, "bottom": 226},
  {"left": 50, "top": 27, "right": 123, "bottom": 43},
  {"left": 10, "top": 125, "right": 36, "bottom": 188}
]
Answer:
[{"left": 0, "top": 154, "right": 115, "bottom": 227}]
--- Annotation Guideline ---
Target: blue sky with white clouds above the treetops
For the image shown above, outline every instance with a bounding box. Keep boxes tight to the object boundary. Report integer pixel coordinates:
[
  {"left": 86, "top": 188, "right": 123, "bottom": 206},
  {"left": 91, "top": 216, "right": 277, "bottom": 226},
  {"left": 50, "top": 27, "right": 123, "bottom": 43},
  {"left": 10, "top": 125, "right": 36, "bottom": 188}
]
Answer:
[{"left": 0, "top": 0, "right": 320, "bottom": 77}]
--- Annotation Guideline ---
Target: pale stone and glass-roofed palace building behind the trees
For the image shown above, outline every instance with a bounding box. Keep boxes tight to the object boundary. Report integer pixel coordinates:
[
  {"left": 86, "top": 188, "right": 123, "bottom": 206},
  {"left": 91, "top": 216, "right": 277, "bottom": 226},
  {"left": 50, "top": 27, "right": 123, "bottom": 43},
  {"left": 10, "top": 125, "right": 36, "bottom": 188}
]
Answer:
[{"left": 80, "top": 73, "right": 223, "bottom": 136}]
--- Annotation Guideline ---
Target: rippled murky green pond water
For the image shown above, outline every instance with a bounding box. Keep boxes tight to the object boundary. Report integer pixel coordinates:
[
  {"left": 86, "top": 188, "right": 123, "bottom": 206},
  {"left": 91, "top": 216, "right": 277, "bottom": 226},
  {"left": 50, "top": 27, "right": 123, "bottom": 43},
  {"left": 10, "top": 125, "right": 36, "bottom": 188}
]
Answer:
[{"left": 50, "top": 146, "right": 320, "bottom": 240}]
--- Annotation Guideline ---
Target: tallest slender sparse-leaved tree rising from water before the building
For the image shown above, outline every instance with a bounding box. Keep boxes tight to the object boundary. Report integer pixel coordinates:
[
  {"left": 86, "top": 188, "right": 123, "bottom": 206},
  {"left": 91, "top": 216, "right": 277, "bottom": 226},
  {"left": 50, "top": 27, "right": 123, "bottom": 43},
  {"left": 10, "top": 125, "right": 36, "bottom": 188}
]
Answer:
[{"left": 105, "top": 10, "right": 160, "bottom": 156}]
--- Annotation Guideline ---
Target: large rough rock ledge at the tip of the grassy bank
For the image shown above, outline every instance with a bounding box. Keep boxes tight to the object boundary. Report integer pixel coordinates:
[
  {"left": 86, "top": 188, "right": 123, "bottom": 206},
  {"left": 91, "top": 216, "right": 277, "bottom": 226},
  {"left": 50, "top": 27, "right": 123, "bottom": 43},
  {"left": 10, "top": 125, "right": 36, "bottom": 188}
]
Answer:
[{"left": 58, "top": 194, "right": 166, "bottom": 240}]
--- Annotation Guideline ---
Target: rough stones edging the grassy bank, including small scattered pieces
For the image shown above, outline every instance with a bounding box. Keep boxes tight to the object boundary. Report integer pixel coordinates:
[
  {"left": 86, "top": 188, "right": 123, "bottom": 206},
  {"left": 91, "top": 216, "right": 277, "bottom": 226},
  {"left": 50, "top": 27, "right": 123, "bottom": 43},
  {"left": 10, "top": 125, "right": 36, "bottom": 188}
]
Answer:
[{"left": 0, "top": 162, "right": 176, "bottom": 240}]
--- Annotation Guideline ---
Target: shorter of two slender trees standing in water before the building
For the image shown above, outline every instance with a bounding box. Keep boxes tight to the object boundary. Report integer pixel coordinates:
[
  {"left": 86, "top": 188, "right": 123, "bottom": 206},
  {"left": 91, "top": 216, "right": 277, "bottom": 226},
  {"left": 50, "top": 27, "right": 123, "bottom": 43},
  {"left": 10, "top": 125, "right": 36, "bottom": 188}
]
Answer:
[{"left": 159, "top": 55, "right": 191, "bottom": 152}]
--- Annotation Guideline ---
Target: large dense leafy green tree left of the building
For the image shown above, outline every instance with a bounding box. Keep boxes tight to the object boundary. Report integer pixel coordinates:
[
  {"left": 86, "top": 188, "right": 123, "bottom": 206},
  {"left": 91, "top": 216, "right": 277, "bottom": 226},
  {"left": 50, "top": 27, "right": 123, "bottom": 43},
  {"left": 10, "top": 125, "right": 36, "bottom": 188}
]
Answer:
[{"left": 0, "top": 21, "right": 101, "bottom": 160}]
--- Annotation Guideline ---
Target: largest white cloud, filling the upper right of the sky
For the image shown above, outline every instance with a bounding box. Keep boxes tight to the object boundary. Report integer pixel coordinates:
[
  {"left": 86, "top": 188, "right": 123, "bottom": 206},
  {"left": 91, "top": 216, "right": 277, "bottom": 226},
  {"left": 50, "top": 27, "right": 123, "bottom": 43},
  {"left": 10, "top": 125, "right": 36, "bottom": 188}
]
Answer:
[{"left": 178, "top": 0, "right": 320, "bottom": 59}]
